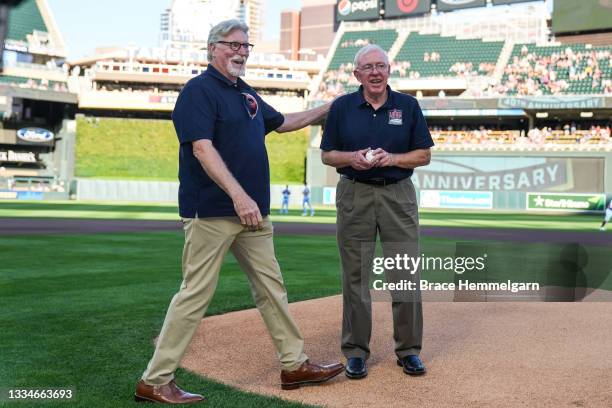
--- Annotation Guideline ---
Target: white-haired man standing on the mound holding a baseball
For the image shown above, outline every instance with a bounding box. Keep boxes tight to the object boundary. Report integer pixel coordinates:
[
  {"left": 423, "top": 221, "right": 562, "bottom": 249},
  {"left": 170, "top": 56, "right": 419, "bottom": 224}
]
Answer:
[{"left": 321, "top": 44, "right": 433, "bottom": 379}]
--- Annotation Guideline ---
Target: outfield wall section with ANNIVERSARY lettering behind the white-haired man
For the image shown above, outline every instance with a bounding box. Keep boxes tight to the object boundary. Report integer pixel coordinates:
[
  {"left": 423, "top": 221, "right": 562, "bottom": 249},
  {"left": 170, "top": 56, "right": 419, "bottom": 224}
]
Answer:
[{"left": 307, "top": 147, "right": 612, "bottom": 212}]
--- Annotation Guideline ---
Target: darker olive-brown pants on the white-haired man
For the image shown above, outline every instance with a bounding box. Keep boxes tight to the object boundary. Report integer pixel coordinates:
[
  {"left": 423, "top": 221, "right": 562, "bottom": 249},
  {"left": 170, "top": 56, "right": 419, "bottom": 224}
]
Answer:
[{"left": 336, "top": 177, "right": 423, "bottom": 358}]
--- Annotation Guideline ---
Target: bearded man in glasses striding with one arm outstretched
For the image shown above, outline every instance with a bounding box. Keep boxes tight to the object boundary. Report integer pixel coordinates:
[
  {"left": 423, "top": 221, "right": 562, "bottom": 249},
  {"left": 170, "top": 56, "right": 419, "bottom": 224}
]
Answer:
[{"left": 135, "top": 20, "right": 344, "bottom": 403}]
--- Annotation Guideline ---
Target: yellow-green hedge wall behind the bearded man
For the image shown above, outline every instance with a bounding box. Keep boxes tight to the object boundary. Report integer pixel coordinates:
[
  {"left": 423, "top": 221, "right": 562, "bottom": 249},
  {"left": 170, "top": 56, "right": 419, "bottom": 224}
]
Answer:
[{"left": 75, "top": 118, "right": 308, "bottom": 183}]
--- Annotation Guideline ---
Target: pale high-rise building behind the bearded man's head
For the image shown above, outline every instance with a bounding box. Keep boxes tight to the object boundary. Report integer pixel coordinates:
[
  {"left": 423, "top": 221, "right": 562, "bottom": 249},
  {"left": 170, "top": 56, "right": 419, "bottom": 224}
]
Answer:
[{"left": 159, "top": 0, "right": 262, "bottom": 49}]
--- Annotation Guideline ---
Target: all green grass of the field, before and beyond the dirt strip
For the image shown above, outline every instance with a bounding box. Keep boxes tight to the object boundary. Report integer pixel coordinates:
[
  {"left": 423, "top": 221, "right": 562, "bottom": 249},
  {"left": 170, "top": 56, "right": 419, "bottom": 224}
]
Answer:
[{"left": 0, "top": 202, "right": 612, "bottom": 407}]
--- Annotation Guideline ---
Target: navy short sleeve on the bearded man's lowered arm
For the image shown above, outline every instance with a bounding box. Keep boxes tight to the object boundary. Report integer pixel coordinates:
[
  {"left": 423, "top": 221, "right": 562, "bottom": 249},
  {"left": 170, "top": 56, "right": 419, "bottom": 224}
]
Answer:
[{"left": 172, "top": 81, "right": 218, "bottom": 144}]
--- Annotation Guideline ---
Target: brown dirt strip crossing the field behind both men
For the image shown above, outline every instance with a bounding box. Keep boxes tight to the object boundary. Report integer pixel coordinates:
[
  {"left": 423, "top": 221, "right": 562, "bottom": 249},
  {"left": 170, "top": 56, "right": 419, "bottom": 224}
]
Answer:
[{"left": 0, "top": 218, "right": 612, "bottom": 246}]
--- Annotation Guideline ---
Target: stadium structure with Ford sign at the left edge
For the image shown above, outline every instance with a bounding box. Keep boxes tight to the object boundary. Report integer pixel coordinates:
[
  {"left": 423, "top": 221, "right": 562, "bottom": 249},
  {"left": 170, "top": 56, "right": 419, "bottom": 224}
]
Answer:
[{"left": 0, "top": 0, "right": 77, "bottom": 199}]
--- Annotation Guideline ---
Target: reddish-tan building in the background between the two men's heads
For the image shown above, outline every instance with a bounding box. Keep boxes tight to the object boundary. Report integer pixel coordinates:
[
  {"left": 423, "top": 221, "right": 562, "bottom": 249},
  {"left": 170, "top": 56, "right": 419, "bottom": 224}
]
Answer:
[{"left": 280, "top": 0, "right": 338, "bottom": 61}]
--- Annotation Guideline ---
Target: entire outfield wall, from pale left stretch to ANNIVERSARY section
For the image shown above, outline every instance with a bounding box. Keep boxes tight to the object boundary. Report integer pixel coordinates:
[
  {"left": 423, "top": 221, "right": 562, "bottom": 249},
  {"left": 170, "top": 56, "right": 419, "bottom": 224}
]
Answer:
[{"left": 76, "top": 148, "right": 612, "bottom": 212}]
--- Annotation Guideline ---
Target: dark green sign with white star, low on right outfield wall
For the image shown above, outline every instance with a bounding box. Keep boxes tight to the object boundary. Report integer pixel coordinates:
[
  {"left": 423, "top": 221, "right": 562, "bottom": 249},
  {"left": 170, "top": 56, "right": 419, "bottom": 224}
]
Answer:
[{"left": 527, "top": 193, "right": 606, "bottom": 212}]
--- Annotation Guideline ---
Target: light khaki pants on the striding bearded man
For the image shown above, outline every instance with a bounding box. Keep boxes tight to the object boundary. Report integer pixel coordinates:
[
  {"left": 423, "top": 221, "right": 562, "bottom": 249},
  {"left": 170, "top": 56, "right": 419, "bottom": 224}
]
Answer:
[{"left": 142, "top": 217, "right": 308, "bottom": 385}]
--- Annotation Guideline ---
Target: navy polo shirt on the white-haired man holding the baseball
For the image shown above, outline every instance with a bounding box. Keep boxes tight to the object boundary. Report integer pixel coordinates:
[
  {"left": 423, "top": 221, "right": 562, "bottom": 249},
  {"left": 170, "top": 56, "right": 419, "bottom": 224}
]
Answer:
[{"left": 321, "top": 86, "right": 434, "bottom": 180}]
